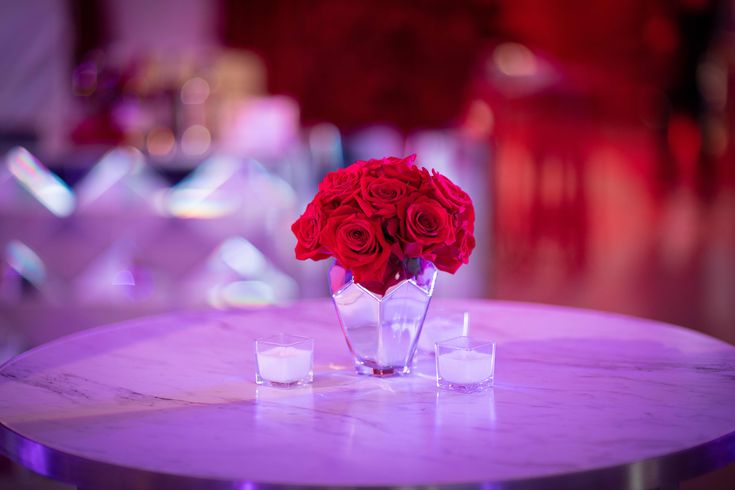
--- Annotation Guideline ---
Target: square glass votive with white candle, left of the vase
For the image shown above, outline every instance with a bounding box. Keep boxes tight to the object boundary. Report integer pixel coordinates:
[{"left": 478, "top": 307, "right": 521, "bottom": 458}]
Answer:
[{"left": 255, "top": 333, "right": 314, "bottom": 388}]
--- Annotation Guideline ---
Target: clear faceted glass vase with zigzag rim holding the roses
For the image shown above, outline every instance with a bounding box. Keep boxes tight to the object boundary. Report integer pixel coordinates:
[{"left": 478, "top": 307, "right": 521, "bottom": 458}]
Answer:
[{"left": 329, "top": 259, "right": 437, "bottom": 377}]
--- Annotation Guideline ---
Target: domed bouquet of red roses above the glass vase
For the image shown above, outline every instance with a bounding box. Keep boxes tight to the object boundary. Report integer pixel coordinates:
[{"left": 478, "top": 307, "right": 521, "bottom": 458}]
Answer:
[{"left": 291, "top": 155, "right": 475, "bottom": 294}]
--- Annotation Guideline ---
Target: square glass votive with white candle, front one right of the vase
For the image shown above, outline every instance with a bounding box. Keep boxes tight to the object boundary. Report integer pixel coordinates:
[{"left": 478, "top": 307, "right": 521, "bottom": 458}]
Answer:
[{"left": 434, "top": 336, "right": 495, "bottom": 393}]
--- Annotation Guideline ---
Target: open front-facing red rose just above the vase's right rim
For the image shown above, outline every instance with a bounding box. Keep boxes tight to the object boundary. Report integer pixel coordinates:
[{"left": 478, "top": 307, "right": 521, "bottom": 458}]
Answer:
[{"left": 401, "top": 196, "right": 454, "bottom": 257}]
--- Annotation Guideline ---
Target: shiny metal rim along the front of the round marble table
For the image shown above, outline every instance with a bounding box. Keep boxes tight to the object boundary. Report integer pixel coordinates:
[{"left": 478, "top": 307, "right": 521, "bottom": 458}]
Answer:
[{"left": 0, "top": 416, "right": 735, "bottom": 490}]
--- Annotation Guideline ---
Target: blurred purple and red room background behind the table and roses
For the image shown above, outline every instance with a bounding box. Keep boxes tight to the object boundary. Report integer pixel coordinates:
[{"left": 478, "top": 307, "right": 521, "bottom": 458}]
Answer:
[{"left": 0, "top": 0, "right": 735, "bottom": 488}]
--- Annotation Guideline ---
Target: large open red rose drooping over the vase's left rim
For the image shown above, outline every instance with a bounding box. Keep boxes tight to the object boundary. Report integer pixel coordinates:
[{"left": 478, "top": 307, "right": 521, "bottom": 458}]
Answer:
[{"left": 321, "top": 206, "right": 391, "bottom": 284}]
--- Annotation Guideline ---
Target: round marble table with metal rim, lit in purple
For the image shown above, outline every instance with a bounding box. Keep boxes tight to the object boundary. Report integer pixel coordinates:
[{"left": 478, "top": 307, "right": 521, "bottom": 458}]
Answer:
[{"left": 0, "top": 301, "right": 735, "bottom": 489}]
